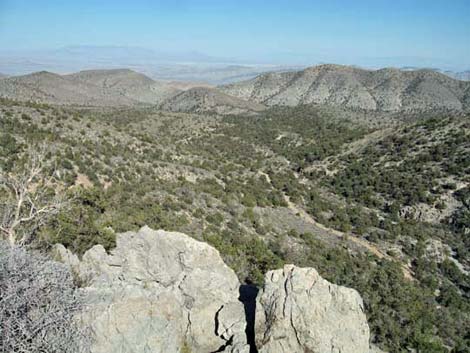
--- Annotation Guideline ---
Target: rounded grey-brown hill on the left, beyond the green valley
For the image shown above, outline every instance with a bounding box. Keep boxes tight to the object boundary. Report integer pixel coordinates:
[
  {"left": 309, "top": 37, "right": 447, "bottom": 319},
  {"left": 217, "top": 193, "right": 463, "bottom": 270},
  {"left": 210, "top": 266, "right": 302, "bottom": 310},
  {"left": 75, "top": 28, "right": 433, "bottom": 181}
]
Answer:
[{"left": 0, "top": 69, "right": 192, "bottom": 107}]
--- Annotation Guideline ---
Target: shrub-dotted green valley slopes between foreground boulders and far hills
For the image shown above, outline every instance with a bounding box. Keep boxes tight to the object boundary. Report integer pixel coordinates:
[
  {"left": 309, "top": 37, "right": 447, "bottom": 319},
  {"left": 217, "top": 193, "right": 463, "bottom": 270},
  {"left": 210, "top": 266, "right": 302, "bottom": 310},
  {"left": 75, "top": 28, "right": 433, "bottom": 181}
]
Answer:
[{"left": 0, "top": 99, "right": 470, "bottom": 352}]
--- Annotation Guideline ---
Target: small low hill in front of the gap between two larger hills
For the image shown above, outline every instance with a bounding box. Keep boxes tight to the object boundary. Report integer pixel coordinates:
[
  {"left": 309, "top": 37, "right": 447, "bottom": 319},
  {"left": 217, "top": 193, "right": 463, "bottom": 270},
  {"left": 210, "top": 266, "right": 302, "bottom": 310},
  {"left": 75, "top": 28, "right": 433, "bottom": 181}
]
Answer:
[{"left": 159, "top": 87, "right": 265, "bottom": 114}]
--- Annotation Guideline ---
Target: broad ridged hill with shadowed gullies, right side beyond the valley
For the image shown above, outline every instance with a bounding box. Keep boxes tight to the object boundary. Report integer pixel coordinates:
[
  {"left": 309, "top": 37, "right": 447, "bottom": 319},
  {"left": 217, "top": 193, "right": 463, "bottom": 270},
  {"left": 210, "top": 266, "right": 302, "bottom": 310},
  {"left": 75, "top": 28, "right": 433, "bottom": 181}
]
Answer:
[{"left": 220, "top": 65, "right": 470, "bottom": 112}]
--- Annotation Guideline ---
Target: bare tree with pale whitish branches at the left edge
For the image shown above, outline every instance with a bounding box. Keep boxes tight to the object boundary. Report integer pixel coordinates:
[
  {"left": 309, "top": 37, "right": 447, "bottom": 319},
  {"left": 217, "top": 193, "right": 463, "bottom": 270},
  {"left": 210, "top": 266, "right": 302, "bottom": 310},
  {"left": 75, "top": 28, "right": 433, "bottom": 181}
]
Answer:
[{"left": 0, "top": 145, "right": 66, "bottom": 245}]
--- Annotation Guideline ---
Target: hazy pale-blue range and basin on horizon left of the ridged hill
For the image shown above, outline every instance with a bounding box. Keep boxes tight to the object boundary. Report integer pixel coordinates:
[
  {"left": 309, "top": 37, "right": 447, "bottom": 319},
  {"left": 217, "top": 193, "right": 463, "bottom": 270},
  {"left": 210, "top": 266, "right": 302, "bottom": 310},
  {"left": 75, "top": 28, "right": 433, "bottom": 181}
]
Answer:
[{"left": 0, "top": 46, "right": 302, "bottom": 84}]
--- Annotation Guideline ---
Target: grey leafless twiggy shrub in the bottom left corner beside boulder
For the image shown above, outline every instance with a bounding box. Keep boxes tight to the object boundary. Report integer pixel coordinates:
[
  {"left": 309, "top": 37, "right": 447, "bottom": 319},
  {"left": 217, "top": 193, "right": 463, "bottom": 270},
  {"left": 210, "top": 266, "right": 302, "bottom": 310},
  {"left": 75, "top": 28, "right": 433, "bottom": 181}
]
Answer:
[{"left": 0, "top": 241, "right": 91, "bottom": 353}]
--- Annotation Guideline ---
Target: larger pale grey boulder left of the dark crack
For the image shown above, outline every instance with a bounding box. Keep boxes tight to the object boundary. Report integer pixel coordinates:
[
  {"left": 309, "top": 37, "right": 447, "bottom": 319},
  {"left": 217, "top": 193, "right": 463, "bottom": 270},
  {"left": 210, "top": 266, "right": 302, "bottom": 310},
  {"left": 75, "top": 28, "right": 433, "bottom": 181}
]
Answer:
[{"left": 56, "top": 227, "right": 249, "bottom": 353}]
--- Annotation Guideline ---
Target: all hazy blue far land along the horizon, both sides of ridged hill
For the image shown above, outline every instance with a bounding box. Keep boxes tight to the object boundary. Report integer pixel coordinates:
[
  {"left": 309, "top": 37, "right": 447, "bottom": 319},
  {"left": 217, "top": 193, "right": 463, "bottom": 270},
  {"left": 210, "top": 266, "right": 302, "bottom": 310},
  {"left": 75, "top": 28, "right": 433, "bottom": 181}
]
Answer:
[{"left": 0, "top": 45, "right": 470, "bottom": 85}]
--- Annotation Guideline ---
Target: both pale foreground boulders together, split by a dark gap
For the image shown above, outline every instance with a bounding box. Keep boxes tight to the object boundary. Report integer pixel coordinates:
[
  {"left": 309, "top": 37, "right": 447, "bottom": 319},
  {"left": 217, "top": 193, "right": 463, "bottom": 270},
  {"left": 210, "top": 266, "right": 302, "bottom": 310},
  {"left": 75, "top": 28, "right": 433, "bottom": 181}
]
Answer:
[{"left": 56, "top": 227, "right": 378, "bottom": 353}]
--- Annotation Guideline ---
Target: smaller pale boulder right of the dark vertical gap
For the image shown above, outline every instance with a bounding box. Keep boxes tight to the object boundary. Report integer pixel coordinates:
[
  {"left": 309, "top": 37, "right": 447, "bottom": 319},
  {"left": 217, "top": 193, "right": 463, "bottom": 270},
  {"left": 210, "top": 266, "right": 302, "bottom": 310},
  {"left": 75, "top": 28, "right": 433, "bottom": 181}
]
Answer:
[{"left": 255, "top": 265, "right": 369, "bottom": 353}]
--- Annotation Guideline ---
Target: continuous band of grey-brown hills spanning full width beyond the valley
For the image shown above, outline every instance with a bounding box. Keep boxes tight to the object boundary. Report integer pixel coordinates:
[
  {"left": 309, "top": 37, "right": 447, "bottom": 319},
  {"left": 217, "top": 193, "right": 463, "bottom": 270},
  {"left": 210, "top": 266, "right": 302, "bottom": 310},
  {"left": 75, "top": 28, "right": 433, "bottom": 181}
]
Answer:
[{"left": 0, "top": 65, "right": 470, "bottom": 114}]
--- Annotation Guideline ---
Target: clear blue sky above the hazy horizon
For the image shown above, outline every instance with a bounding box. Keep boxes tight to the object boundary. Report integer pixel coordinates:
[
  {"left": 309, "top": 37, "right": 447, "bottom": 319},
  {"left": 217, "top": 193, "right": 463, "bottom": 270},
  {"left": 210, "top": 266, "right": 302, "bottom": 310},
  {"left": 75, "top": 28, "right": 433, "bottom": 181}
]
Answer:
[{"left": 0, "top": 0, "right": 470, "bottom": 68}]
